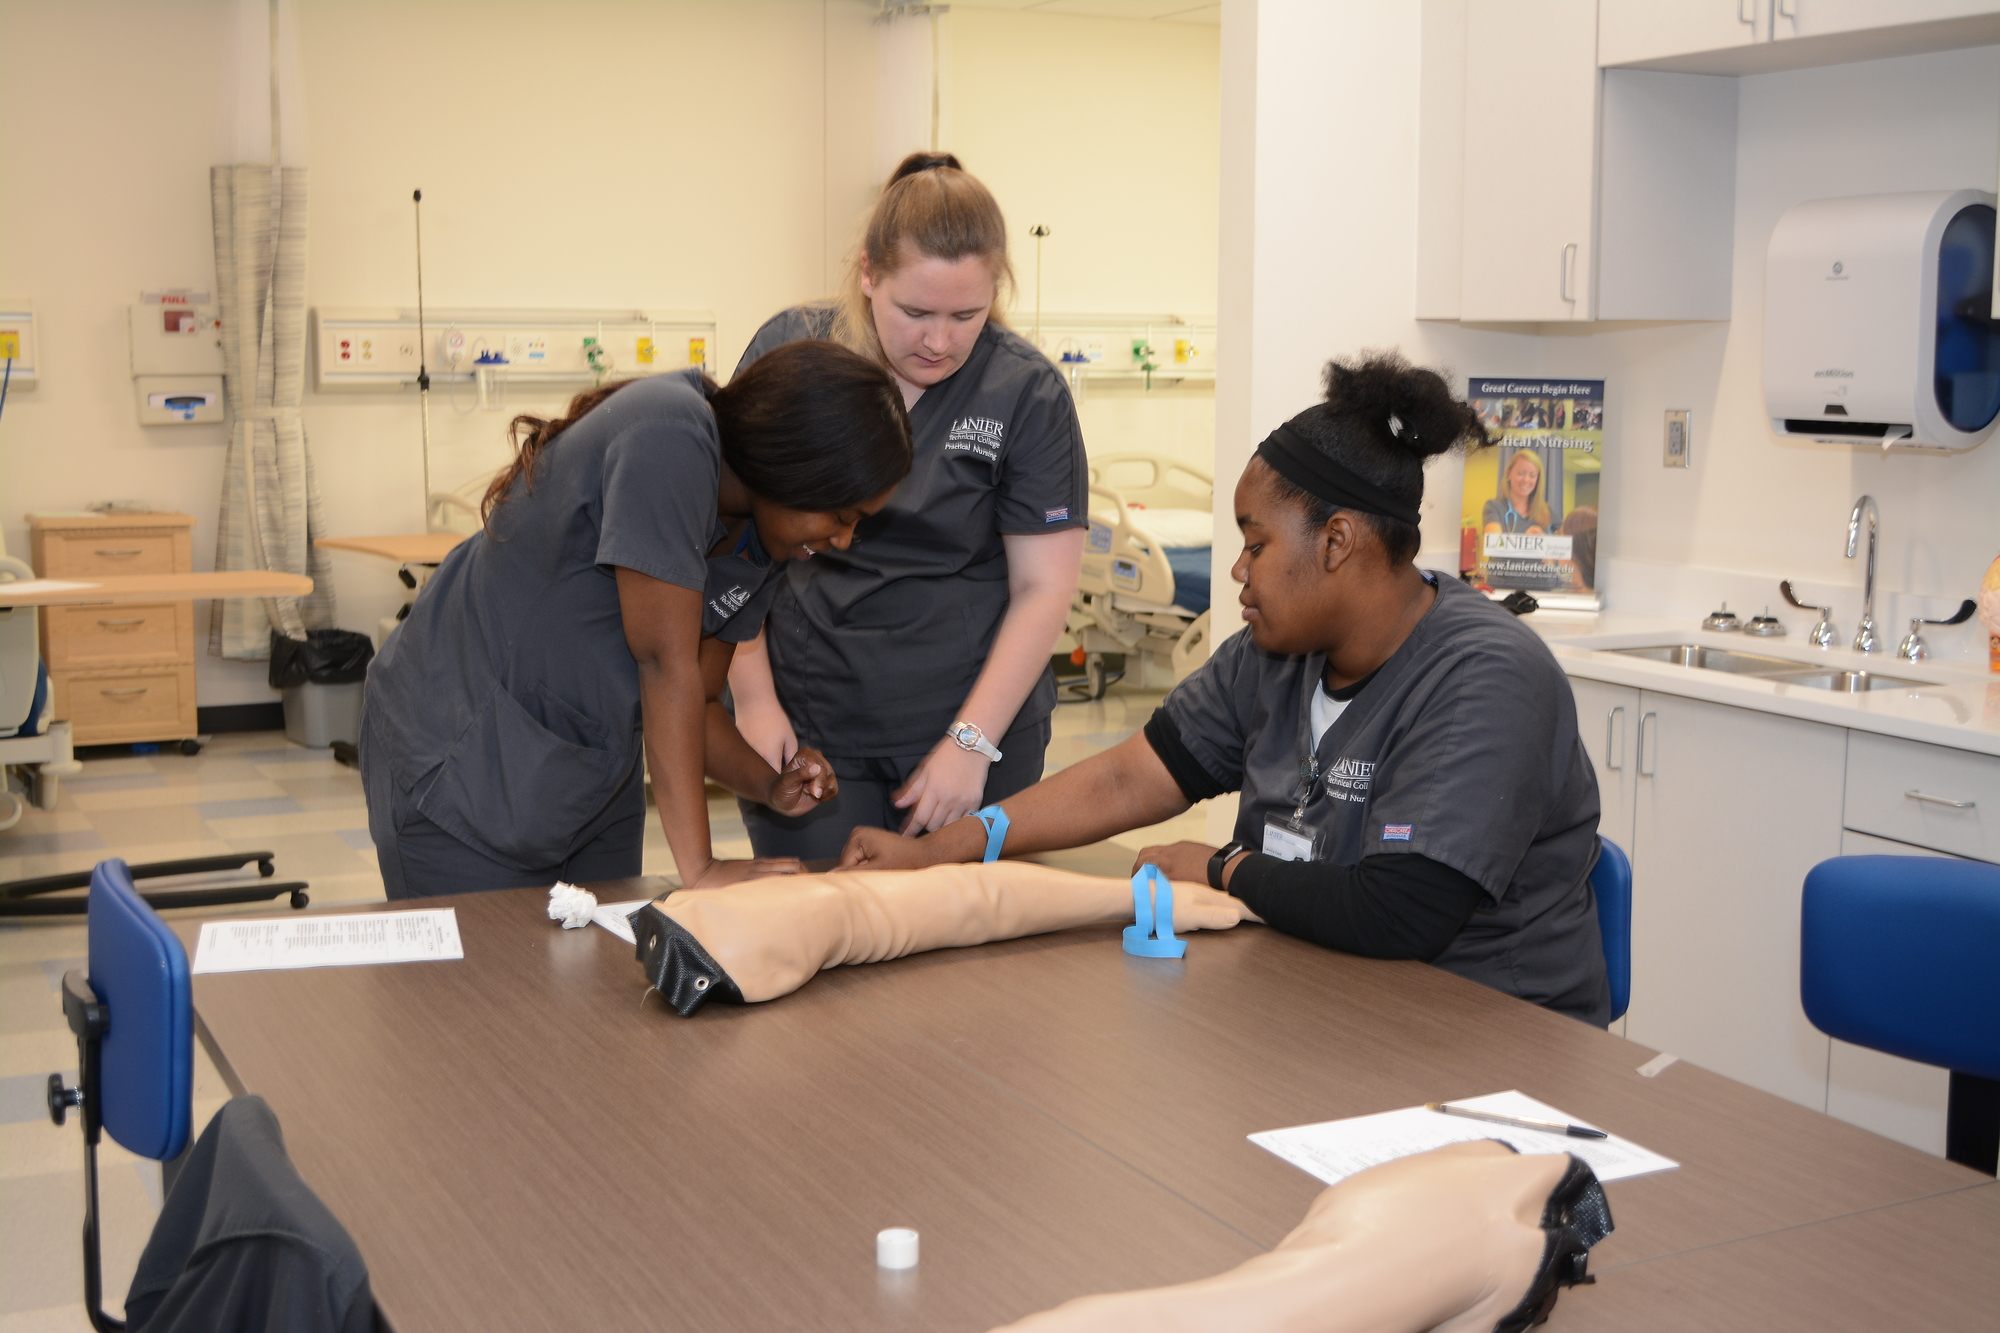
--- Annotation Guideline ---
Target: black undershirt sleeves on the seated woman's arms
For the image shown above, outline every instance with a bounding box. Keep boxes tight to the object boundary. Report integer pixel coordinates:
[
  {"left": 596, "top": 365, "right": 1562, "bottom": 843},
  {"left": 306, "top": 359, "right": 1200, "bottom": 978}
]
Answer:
[{"left": 1146, "top": 709, "right": 1484, "bottom": 963}]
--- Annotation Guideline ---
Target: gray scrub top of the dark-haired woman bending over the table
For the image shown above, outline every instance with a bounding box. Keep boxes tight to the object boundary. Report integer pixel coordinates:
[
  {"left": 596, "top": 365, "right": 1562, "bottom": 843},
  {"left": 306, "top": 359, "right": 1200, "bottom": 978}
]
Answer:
[{"left": 366, "top": 370, "right": 778, "bottom": 867}]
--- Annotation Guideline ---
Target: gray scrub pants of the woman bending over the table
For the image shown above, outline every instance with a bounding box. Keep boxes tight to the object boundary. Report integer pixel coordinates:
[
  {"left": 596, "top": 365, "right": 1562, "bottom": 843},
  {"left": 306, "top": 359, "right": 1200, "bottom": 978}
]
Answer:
[{"left": 362, "top": 727, "right": 646, "bottom": 901}]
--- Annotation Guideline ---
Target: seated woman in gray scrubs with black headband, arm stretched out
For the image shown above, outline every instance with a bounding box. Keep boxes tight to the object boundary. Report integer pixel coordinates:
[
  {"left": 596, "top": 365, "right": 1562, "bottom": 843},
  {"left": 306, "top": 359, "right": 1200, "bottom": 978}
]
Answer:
[{"left": 844, "top": 354, "right": 1610, "bottom": 1025}]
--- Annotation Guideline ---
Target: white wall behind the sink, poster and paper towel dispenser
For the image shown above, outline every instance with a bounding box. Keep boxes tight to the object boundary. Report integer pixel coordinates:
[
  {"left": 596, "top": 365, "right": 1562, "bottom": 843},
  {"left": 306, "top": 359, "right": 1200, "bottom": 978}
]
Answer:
[{"left": 1216, "top": 0, "right": 2000, "bottom": 658}]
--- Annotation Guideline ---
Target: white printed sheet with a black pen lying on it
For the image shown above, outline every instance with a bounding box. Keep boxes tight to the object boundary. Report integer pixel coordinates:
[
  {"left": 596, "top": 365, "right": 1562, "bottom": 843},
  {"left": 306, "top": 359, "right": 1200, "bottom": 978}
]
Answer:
[{"left": 1250, "top": 1093, "right": 1680, "bottom": 1185}]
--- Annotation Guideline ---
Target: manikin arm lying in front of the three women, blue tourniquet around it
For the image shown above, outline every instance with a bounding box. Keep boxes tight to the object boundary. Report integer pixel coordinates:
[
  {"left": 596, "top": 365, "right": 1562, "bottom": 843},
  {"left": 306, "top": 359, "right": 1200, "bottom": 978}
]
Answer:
[{"left": 632, "top": 861, "right": 1248, "bottom": 1015}]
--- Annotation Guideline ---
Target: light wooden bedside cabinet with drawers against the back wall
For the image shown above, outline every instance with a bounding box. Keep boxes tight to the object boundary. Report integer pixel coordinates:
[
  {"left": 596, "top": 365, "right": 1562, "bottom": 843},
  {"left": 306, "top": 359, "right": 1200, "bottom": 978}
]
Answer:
[{"left": 28, "top": 514, "right": 196, "bottom": 745}]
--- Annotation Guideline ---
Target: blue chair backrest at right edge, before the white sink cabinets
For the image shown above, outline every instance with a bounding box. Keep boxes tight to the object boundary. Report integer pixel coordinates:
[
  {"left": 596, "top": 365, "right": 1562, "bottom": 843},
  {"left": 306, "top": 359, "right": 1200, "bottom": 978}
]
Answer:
[{"left": 1798, "top": 857, "right": 2000, "bottom": 1079}]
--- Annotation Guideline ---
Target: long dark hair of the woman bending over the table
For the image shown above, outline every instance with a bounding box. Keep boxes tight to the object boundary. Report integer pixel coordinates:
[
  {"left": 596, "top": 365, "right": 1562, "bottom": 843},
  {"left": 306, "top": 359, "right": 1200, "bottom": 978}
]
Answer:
[{"left": 480, "top": 342, "right": 912, "bottom": 520}]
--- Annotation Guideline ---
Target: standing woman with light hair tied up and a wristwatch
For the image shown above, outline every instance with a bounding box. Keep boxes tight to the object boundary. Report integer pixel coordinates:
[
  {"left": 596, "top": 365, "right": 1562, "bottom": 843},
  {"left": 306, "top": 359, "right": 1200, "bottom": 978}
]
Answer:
[{"left": 730, "top": 154, "right": 1088, "bottom": 861}]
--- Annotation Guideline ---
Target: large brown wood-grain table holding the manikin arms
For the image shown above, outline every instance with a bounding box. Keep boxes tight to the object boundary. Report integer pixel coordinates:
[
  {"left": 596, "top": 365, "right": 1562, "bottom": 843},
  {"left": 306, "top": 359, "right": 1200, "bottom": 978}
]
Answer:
[{"left": 182, "top": 881, "right": 2000, "bottom": 1331}]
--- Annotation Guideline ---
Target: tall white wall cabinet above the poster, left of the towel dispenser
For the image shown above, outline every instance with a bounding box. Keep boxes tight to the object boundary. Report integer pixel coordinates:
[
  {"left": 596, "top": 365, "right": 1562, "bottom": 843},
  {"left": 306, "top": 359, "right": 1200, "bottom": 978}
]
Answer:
[{"left": 1416, "top": 0, "right": 1736, "bottom": 324}]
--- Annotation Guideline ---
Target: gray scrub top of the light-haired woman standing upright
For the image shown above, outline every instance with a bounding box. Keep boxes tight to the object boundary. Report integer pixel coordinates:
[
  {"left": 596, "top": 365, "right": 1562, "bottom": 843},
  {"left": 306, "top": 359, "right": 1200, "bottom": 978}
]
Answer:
[{"left": 738, "top": 306, "right": 1090, "bottom": 757}]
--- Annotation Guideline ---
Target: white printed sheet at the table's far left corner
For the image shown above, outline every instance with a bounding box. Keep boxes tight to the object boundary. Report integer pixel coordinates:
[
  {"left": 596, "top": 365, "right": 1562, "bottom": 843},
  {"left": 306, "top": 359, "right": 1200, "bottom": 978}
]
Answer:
[{"left": 192, "top": 907, "right": 466, "bottom": 973}]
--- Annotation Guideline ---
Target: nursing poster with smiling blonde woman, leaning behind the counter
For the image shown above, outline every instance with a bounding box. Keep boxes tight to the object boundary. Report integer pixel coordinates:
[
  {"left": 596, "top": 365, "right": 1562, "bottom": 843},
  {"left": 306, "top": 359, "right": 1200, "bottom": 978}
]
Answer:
[{"left": 1458, "top": 376, "right": 1604, "bottom": 610}]
